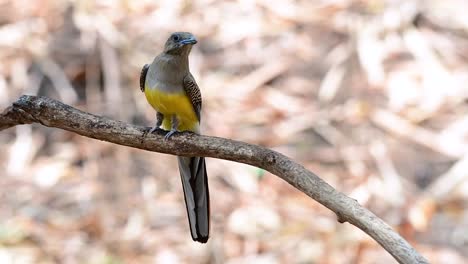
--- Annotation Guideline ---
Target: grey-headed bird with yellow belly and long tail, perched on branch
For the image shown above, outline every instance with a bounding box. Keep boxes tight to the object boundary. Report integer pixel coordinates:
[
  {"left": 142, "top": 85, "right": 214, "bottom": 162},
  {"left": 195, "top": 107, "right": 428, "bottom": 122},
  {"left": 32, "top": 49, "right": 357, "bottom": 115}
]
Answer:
[{"left": 140, "top": 32, "right": 210, "bottom": 243}]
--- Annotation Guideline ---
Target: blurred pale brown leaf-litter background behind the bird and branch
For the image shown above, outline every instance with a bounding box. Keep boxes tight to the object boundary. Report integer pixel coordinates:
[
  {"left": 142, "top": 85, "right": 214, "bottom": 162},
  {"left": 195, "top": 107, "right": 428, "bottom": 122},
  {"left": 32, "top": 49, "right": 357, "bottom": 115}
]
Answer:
[{"left": 0, "top": 0, "right": 468, "bottom": 264}]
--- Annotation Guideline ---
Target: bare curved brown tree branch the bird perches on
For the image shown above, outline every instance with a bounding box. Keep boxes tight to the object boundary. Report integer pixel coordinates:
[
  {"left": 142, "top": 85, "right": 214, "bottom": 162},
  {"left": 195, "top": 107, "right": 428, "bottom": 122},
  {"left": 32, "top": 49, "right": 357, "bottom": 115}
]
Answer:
[{"left": 0, "top": 95, "right": 428, "bottom": 263}]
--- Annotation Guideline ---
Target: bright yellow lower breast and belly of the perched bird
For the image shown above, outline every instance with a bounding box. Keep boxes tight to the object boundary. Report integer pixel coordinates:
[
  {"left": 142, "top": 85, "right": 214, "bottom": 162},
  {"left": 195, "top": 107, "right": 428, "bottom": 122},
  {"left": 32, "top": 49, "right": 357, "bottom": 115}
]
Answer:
[{"left": 145, "top": 87, "right": 199, "bottom": 132}]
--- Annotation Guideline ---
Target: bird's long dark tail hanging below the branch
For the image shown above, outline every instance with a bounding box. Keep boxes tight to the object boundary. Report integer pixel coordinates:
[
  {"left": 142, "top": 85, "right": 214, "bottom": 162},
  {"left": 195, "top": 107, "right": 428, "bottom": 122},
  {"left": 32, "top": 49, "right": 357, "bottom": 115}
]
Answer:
[{"left": 177, "top": 157, "right": 210, "bottom": 243}]
